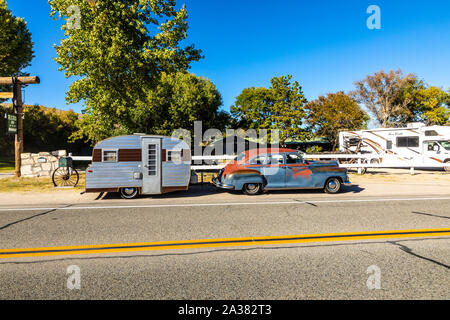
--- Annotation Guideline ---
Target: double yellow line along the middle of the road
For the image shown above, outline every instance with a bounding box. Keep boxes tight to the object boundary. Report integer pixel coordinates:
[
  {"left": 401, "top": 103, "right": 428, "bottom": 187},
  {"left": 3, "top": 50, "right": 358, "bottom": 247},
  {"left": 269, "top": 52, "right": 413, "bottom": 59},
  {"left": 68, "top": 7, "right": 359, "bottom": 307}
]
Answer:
[{"left": 0, "top": 229, "right": 450, "bottom": 258}]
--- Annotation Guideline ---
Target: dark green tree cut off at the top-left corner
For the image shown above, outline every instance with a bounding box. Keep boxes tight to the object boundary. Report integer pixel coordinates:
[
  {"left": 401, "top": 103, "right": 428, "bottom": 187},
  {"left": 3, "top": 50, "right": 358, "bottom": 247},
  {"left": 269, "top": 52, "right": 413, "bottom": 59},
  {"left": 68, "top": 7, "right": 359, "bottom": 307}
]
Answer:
[{"left": 0, "top": 0, "right": 34, "bottom": 96}]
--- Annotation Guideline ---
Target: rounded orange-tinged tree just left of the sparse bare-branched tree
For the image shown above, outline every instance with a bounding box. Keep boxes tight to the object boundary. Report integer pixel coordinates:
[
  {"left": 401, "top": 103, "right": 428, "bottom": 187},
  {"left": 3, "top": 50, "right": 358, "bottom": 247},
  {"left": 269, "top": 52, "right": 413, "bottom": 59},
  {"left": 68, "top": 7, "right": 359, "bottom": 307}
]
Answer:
[{"left": 306, "top": 91, "right": 370, "bottom": 150}]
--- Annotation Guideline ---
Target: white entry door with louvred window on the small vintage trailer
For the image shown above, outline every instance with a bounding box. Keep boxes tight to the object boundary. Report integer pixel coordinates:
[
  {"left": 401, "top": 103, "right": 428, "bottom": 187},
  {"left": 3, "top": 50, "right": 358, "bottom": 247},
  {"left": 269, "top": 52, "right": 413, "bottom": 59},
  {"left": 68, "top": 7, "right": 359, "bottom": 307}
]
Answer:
[{"left": 142, "top": 137, "right": 162, "bottom": 194}]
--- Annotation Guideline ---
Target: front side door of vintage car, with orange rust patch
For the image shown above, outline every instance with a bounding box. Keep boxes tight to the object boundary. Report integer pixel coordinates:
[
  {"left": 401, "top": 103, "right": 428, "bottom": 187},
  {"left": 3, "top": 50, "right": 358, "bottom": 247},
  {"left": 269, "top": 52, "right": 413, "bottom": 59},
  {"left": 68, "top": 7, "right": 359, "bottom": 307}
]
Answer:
[{"left": 286, "top": 153, "right": 313, "bottom": 188}]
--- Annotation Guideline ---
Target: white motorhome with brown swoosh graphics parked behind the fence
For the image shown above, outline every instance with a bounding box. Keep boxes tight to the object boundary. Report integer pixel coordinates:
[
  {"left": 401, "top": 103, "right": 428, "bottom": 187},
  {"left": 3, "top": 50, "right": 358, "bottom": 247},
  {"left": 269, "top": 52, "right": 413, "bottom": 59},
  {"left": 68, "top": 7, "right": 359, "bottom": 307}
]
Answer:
[{"left": 339, "top": 123, "right": 450, "bottom": 170}]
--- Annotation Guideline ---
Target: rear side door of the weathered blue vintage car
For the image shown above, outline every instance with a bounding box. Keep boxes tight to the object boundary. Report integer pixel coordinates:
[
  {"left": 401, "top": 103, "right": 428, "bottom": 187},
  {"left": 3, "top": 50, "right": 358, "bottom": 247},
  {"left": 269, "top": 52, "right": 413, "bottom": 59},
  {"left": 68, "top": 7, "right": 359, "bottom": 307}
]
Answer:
[{"left": 262, "top": 153, "right": 286, "bottom": 189}]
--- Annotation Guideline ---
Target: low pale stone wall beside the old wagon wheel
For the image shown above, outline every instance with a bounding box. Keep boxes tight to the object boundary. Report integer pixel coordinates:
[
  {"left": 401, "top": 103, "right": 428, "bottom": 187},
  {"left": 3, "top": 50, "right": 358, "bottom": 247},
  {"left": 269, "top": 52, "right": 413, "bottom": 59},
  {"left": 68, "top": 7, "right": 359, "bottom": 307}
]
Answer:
[{"left": 20, "top": 150, "right": 67, "bottom": 177}]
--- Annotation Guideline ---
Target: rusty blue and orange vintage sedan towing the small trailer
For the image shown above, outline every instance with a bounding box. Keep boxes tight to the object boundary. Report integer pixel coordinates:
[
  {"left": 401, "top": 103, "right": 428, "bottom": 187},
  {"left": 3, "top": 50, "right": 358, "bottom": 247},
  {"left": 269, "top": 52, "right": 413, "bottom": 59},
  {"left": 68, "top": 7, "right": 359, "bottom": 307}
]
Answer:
[{"left": 213, "top": 148, "right": 350, "bottom": 195}]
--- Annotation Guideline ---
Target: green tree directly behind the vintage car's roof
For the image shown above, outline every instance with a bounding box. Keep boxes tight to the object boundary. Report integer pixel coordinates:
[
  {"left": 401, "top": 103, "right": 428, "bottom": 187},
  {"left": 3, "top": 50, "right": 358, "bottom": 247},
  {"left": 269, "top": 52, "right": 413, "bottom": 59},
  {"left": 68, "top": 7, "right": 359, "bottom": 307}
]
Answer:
[{"left": 231, "top": 75, "right": 307, "bottom": 143}]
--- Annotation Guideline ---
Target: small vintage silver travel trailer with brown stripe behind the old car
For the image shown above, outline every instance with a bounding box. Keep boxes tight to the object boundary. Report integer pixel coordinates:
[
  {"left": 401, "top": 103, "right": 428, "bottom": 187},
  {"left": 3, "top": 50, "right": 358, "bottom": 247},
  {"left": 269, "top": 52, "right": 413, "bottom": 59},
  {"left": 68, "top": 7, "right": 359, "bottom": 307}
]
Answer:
[{"left": 86, "top": 134, "right": 191, "bottom": 199}]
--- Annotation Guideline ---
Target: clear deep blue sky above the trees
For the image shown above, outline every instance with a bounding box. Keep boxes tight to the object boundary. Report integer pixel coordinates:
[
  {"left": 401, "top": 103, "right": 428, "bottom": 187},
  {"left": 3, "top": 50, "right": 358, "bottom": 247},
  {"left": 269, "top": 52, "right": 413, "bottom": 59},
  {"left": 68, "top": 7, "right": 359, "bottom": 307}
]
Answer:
[{"left": 7, "top": 0, "right": 450, "bottom": 112}]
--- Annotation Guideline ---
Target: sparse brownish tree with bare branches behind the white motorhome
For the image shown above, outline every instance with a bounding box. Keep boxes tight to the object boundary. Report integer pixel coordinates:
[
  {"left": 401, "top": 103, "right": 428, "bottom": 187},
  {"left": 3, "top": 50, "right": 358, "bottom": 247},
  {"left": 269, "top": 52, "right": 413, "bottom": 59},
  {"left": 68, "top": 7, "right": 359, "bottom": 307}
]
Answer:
[{"left": 352, "top": 70, "right": 421, "bottom": 127}]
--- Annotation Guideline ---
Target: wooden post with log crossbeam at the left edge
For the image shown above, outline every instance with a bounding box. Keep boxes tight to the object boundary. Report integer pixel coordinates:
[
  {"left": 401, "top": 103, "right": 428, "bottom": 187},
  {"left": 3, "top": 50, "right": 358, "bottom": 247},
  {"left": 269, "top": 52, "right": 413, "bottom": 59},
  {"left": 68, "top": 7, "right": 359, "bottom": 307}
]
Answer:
[{"left": 0, "top": 77, "right": 41, "bottom": 177}]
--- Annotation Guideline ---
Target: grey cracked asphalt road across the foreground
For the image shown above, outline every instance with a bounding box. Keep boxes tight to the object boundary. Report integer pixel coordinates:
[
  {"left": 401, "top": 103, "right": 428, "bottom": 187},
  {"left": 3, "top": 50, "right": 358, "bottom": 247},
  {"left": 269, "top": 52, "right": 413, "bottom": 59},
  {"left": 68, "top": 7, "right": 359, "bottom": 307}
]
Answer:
[{"left": 0, "top": 186, "right": 450, "bottom": 299}]
